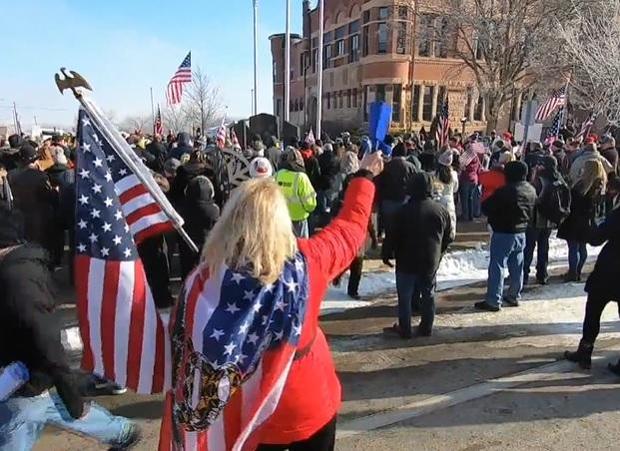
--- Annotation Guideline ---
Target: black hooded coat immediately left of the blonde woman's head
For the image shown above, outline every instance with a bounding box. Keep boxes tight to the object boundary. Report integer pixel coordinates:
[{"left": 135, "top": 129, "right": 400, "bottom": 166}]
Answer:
[{"left": 181, "top": 176, "right": 220, "bottom": 249}]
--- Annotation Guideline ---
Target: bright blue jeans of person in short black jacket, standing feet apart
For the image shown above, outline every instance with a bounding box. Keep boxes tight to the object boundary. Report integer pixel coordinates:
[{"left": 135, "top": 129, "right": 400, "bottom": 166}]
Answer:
[{"left": 486, "top": 232, "right": 525, "bottom": 307}]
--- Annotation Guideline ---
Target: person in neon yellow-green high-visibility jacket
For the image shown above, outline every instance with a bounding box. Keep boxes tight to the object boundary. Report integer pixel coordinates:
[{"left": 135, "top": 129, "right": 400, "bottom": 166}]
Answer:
[{"left": 275, "top": 147, "right": 317, "bottom": 238}]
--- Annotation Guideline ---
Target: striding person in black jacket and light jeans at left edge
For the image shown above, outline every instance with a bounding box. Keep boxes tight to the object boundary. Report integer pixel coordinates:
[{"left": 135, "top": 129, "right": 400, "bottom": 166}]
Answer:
[{"left": 0, "top": 204, "right": 140, "bottom": 450}]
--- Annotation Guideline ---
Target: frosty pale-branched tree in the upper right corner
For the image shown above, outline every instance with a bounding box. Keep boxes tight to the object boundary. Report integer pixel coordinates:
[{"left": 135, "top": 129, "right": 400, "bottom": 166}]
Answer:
[{"left": 558, "top": 0, "right": 620, "bottom": 125}]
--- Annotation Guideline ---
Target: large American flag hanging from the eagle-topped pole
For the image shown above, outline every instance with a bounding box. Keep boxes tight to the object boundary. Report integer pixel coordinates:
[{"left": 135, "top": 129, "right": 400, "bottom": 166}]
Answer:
[{"left": 75, "top": 110, "right": 173, "bottom": 393}]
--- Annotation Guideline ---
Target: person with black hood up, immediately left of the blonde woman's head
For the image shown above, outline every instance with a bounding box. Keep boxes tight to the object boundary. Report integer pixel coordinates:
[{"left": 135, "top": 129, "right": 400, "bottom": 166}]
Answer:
[{"left": 179, "top": 175, "right": 220, "bottom": 279}]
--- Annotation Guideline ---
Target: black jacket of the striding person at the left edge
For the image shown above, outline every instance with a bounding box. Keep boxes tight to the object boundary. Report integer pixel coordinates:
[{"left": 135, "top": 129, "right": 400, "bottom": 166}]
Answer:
[{"left": 0, "top": 244, "right": 84, "bottom": 418}]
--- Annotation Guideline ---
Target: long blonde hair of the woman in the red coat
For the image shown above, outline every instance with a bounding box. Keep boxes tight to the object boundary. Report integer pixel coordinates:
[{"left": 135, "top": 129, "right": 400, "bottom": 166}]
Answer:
[{"left": 202, "top": 179, "right": 297, "bottom": 283}]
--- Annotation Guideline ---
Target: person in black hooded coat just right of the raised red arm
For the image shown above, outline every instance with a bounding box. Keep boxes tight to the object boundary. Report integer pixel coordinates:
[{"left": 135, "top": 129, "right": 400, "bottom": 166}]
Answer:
[{"left": 382, "top": 173, "right": 452, "bottom": 338}]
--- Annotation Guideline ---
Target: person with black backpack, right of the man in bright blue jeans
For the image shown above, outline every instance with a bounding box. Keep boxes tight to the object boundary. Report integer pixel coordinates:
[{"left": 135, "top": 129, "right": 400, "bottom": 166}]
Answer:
[{"left": 523, "top": 155, "right": 571, "bottom": 285}]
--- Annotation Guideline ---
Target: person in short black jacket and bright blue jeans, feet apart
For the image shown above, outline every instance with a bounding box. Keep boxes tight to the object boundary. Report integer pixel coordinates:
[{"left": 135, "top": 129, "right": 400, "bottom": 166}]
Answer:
[{"left": 475, "top": 161, "right": 536, "bottom": 312}]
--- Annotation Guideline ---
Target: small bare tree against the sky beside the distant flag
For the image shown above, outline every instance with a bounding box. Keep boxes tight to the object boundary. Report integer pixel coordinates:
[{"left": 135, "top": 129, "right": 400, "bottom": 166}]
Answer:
[{"left": 183, "top": 66, "right": 222, "bottom": 133}]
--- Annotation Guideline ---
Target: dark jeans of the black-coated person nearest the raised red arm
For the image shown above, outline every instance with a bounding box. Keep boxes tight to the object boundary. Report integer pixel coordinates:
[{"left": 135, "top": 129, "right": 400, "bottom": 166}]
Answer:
[{"left": 396, "top": 271, "right": 435, "bottom": 336}]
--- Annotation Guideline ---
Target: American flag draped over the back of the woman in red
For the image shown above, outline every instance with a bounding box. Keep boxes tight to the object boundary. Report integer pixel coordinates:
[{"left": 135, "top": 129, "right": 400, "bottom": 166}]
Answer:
[{"left": 159, "top": 254, "right": 308, "bottom": 451}]
